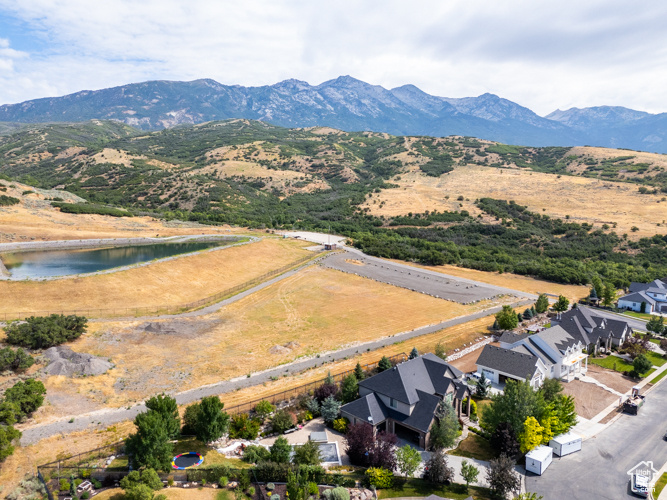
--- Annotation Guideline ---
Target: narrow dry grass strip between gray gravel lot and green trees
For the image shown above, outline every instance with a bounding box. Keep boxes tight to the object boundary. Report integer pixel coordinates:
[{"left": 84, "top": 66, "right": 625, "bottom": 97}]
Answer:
[{"left": 395, "top": 260, "right": 590, "bottom": 301}]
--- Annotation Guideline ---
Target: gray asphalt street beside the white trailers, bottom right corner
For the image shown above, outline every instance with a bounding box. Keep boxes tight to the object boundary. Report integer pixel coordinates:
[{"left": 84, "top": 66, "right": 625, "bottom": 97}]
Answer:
[{"left": 526, "top": 382, "right": 667, "bottom": 500}]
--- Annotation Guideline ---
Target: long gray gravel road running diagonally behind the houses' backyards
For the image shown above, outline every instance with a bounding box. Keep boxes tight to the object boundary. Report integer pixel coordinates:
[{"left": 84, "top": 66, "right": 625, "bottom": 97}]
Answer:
[{"left": 21, "top": 300, "right": 533, "bottom": 446}]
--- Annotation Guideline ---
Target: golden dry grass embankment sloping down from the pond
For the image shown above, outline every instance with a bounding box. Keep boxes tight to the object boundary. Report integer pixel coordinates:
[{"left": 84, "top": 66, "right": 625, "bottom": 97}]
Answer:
[{"left": 0, "top": 238, "right": 313, "bottom": 316}]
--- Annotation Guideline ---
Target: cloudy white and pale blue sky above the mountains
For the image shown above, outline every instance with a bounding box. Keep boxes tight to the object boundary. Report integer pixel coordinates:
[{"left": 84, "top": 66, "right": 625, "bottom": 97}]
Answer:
[{"left": 0, "top": 0, "right": 667, "bottom": 115}]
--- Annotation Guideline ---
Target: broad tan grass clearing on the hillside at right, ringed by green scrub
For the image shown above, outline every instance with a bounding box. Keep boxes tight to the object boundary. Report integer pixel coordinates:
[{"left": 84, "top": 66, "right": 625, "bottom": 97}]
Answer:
[{"left": 364, "top": 166, "right": 667, "bottom": 238}]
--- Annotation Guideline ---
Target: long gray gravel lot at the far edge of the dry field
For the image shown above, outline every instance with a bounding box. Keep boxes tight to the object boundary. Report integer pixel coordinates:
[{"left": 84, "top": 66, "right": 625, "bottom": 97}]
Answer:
[{"left": 321, "top": 252, "right": 521, "bottom": 304}]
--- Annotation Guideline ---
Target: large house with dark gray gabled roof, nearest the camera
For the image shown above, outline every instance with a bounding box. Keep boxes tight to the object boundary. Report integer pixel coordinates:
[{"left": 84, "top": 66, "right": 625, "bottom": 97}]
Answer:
[{"left": 341, "top": 353, "right": 470, "bottom": 448}]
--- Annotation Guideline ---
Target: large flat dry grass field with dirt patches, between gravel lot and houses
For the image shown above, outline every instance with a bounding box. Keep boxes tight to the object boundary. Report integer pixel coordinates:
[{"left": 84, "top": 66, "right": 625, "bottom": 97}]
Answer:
[{"left": 31, "top": 267, "right": 507, "bottom": 421}]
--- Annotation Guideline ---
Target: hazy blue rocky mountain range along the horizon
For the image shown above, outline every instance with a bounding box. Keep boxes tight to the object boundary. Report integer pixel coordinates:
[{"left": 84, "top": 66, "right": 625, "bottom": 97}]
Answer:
[{"left": 0, "top": 76, "right": 667, "bottom": 153}]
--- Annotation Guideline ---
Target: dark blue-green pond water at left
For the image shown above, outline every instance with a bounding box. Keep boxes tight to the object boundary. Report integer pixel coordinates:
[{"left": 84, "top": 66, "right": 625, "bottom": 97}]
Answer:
[{"left": 2, "top": 241, "right": 228, "bottom": 280}]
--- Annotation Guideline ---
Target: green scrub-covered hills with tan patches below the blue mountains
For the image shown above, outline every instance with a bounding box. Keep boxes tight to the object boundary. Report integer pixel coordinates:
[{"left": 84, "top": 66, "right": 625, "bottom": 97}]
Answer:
[{"left": 0, "top": 120, "right": 667, "bottom": 286}]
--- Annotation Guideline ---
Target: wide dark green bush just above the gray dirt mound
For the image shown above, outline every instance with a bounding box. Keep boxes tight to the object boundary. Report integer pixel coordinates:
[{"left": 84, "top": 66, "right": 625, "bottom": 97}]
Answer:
[{"left": 5, "top": 314, "right": 88, "bottom": 349}]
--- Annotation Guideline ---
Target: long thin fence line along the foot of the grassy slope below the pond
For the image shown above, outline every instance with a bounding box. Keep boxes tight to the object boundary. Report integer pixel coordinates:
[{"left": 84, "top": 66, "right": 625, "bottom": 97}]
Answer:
[{"left": 0, "top": 255, "right": 321, "bottom": 322}]
